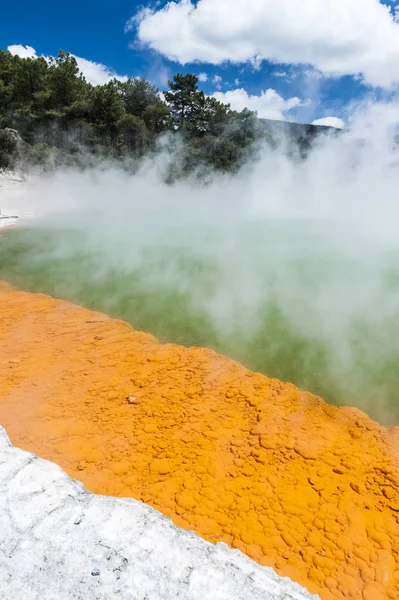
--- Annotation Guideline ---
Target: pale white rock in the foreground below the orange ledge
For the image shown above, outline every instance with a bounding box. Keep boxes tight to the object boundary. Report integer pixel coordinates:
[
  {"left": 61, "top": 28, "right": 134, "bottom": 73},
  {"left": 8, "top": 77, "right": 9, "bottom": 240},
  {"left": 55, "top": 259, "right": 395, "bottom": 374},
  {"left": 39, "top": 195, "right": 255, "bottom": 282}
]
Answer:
[{"left": 0, "top": 427, "right": 318, "bottom": 600}]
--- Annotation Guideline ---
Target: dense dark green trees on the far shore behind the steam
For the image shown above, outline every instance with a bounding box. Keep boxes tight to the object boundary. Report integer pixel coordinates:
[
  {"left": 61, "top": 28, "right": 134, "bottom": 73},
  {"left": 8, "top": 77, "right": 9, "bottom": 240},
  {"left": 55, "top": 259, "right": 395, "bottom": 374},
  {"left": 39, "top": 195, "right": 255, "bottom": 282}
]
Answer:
[{"left": 0, "top": 50, "right": 332, "bottom": 176}]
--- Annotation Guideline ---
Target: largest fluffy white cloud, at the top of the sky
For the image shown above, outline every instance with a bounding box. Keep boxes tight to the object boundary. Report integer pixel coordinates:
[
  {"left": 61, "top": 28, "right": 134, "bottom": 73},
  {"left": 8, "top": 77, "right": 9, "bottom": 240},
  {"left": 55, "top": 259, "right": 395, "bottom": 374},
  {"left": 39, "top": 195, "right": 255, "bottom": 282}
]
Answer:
[{"left": 134, "top": 0, "right": 399, "bottom": 87}]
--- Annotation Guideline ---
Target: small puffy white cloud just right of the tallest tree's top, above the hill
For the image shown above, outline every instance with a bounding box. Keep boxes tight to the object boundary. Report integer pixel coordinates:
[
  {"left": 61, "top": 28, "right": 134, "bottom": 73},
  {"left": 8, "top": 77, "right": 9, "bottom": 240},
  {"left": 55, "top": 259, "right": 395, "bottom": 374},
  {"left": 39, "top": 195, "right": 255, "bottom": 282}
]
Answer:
[{"left": 213, "top": 88, "right": 303, "bottom": 120}]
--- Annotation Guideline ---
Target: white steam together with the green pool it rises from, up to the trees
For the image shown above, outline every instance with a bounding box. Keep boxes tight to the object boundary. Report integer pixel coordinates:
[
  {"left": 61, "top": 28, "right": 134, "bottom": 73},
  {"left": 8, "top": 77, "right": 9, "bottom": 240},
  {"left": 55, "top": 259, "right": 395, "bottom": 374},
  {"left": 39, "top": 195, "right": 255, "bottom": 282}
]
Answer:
[{"left": 0, "top": 104, "right": 399, "bottom": 425}]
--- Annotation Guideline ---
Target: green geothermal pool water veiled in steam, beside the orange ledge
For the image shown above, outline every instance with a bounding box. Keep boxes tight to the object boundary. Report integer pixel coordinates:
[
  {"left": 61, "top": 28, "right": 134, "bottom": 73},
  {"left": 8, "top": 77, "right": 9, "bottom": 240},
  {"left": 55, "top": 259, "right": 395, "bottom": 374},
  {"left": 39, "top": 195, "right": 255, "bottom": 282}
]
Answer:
[{"left": 0, "top": 219, "right": 399, "bottom": 425}]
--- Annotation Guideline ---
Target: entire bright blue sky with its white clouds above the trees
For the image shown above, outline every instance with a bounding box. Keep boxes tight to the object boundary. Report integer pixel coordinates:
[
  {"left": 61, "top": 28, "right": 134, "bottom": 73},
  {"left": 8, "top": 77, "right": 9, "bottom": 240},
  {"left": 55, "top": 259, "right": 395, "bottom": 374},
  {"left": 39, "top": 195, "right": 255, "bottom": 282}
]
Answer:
[{"left": 0, "top": 0, "right": 399, "bottom": 124}]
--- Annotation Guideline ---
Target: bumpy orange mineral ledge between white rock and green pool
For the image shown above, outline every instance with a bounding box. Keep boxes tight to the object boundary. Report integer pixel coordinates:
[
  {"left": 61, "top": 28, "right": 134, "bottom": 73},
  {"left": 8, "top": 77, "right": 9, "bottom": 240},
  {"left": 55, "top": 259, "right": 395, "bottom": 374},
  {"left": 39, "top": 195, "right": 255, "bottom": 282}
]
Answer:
[{"left": 0, "top": 284, "right": 399, "bottom": 600}]
